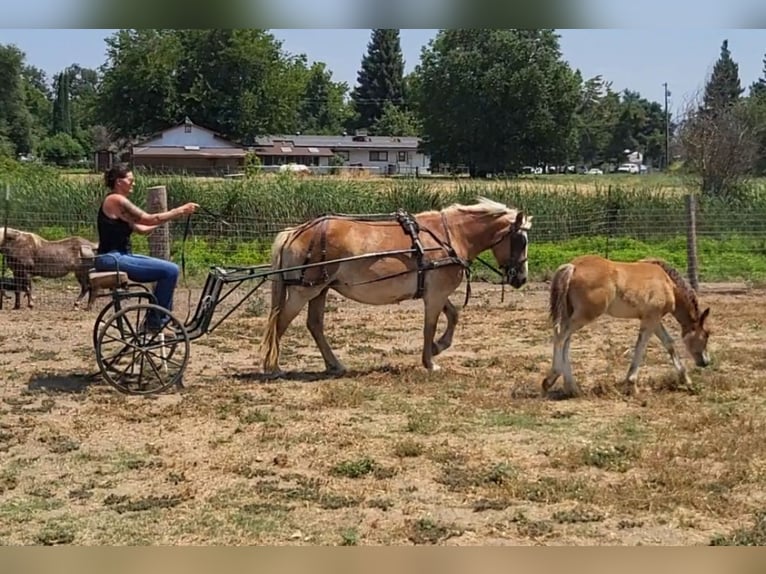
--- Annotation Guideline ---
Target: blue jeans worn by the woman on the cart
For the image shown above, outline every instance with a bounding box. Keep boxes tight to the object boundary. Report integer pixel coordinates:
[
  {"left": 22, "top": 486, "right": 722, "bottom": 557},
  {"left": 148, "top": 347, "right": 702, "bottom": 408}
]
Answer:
[{"left": 95, "top": 251, "right": 178, "bottom": 326}]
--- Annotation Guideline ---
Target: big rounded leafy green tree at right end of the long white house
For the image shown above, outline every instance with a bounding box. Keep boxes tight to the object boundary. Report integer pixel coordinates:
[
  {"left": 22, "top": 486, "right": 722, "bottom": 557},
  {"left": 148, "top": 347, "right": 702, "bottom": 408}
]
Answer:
[{"left": 416, "top": 29, "right": 581, "bottom": 175}]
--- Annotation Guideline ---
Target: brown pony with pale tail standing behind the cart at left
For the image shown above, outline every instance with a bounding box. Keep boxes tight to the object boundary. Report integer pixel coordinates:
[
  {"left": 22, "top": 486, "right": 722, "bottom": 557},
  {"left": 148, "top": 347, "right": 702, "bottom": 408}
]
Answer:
[{"left": 0, "top": 227, "right": 96, "bottom": 309}]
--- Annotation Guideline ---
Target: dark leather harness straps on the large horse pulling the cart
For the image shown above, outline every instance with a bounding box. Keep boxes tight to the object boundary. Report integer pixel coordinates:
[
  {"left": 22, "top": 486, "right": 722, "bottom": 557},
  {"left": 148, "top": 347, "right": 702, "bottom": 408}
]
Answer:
[{"left": 285, "top": 209, "right": 470, "bottom": 300}]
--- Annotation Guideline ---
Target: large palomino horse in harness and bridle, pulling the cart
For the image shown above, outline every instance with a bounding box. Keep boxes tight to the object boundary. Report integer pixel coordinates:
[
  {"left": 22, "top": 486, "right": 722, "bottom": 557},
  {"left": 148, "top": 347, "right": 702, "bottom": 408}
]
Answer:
[{"left": 262, "top": 198, "right": 532, "bottom": 375}]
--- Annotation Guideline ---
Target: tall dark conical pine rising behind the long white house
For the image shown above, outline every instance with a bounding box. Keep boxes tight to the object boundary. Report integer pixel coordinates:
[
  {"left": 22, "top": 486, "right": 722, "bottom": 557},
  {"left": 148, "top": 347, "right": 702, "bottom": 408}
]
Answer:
[{"left": 351, "top": 28, "right": 404, "bottom": 133}]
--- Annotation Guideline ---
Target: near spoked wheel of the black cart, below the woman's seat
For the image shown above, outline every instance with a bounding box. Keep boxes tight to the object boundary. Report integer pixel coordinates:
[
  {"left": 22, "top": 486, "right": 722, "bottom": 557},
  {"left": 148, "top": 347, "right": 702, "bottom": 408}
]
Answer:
[{"left": 96, "top": 303, "right": 189, "bottom": 395}]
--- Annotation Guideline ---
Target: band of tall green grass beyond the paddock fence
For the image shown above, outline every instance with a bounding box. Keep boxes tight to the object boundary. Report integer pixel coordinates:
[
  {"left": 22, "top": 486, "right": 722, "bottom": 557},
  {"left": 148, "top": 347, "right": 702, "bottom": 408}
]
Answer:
[{"left": 0, "top": 164, "right": 766, "bottom": 279}]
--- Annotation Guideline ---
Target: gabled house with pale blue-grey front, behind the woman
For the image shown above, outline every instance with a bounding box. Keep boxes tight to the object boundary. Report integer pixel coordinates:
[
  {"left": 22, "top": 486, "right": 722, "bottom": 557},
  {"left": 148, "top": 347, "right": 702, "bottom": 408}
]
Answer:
[{"left": 131, "top": 117, "right": 247, "bottom": 175}]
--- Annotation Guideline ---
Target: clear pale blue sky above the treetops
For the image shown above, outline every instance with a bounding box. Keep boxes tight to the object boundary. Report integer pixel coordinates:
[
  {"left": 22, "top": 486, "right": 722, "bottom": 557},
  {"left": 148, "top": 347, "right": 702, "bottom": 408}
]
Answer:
[{"left": 0, "top": 28, "right": 766, "bottom": 117}]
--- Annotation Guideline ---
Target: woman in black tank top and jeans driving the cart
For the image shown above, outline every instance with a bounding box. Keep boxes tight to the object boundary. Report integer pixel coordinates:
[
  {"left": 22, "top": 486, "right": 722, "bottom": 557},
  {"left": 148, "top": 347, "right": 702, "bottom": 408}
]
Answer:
[{"left": 95, "top": 163, "right": 199, "bottom": 331}]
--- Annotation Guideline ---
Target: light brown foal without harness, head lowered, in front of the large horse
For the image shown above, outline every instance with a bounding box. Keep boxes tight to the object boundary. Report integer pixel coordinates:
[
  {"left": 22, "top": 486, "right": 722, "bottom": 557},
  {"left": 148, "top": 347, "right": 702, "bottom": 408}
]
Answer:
[{"left": 543, "top": 255, "right": 710, "bottom": 396}]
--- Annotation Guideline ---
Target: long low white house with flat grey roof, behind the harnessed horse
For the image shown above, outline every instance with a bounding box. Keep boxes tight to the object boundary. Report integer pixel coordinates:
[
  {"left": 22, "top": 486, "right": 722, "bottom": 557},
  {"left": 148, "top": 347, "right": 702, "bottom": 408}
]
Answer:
[{"left": 253, "top": 134, "right": 431, "bottom": 175}]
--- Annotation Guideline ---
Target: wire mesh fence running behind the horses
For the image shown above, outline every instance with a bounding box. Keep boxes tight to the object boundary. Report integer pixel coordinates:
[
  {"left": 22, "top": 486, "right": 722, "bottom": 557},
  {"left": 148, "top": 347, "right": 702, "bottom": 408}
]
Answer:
[{"left": 0, "top": 194, "right": 766, "bottom": 310}]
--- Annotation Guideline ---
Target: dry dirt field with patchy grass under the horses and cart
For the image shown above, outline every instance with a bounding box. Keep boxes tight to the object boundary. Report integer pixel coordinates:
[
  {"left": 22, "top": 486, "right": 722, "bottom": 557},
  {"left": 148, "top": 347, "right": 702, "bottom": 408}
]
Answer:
[{"left": 0, "top": 284, "right": 766, "bottom": 545}]
